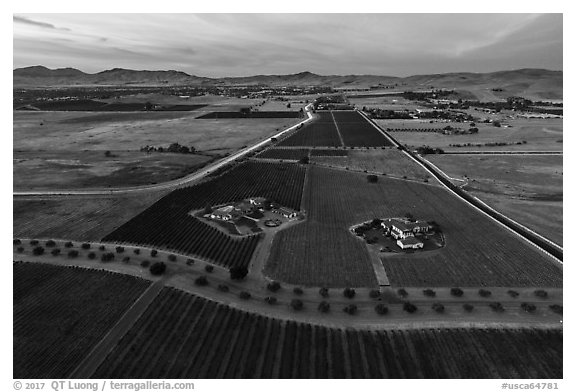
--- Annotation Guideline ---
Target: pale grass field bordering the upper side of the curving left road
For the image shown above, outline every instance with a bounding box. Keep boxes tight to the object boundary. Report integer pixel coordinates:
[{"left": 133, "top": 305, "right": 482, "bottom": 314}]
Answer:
[{"left": 12, "top": 151, "right": 214, "bottom": 191}]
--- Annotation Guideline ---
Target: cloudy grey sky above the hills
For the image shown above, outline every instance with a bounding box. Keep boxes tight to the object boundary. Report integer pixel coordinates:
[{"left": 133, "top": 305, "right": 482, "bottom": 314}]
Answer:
[{"left": 13, "top": 13, "right": 563, "bottom": 77}]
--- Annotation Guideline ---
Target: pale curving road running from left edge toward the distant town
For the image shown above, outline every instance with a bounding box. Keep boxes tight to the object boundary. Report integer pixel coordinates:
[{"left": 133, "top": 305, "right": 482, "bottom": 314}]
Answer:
[{"left": 12, "top": 104, "right": 313, "bottom": 197}]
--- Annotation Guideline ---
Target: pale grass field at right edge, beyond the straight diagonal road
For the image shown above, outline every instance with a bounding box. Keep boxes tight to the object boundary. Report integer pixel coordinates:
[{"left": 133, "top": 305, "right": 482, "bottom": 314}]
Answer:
[{"left": 426, "top": 155, "right": 563, "bottom": 244}]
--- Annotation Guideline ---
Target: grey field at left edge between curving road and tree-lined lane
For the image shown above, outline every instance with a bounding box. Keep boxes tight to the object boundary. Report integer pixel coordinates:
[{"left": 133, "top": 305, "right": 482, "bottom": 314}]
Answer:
[{"left": 13, "top": 192, "right": 165, "bottom": 241}]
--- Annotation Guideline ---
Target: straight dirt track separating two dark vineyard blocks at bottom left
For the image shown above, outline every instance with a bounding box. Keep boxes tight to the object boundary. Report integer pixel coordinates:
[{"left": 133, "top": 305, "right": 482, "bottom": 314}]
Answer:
[{"left": 70, "top": 279, "right": 164, "bottom": 379}]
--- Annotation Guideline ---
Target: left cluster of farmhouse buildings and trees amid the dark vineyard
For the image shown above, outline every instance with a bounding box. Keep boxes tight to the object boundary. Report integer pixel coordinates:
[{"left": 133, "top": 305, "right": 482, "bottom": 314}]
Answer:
[{"left": 210, "top": 197, "right": 297, "bottom": 222}]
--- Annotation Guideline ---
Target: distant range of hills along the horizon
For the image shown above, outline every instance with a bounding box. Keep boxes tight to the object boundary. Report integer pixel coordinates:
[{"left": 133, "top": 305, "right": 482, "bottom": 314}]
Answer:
[{"left": 13, "top": 66, "right": 563, "bottom": 99}]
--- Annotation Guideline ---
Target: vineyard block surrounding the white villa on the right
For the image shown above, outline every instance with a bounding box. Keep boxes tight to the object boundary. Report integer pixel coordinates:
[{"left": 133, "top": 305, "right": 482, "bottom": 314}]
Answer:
[{"left": 267, "top": 166, "right": 562, "bottom": 287}]
